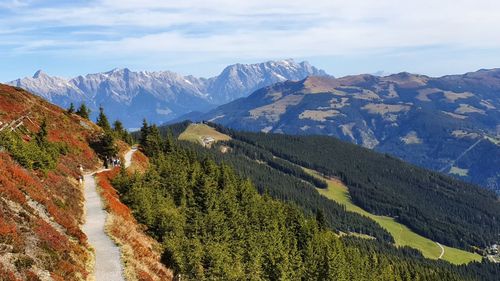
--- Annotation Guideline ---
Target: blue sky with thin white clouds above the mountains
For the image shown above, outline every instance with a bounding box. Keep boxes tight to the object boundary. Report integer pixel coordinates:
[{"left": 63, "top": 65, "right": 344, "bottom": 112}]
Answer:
[{"left": 0, "top": 0, "right": 500, "bottom": 81}]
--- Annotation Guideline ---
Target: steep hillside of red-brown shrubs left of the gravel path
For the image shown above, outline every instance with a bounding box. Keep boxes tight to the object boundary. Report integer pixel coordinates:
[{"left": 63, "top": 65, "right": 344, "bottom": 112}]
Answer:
[{"left": 0, "top": 84, "right": 170, "bottom": 281}]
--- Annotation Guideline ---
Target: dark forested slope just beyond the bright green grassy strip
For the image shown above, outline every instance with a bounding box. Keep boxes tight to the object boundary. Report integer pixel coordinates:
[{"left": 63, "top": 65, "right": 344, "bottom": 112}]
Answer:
[{"left": 214, "top": 128, "right": 500, "bottom": 248}]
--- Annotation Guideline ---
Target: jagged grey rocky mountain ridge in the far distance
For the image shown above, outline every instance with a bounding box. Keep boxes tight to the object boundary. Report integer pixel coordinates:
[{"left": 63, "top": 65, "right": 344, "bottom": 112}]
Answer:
[{"left": 7, "top": 59, "right": 327, "bottom": 128}]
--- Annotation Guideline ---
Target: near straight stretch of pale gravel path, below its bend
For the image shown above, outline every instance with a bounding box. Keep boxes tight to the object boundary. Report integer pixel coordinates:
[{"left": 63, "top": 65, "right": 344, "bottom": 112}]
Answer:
[{"left": 83, "top": 171, "right": 125, "bottom": 281}]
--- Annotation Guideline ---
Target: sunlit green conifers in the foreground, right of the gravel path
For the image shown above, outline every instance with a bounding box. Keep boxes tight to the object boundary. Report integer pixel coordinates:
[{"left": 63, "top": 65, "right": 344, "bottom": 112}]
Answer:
[{"left": 113, "top": 126, "right": 494, "bottom": 280}]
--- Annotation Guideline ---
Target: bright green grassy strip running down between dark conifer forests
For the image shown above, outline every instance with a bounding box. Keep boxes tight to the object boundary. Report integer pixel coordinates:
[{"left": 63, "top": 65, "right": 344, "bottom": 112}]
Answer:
[{"left": 307, "top": 167, "right": 481, "bottom": 264}]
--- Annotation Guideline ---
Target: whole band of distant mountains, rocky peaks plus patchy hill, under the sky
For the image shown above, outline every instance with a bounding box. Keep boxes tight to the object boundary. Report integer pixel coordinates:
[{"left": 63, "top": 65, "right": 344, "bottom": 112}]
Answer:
[{"left": 9, "top": 59, "right": 500, "bottom": 192}]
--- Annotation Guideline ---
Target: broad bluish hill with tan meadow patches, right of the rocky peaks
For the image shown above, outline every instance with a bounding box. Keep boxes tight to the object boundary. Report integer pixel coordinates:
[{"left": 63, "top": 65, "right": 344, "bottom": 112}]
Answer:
[{"left": 191, "top": 69, "right": 500, "bottom": 192}]
